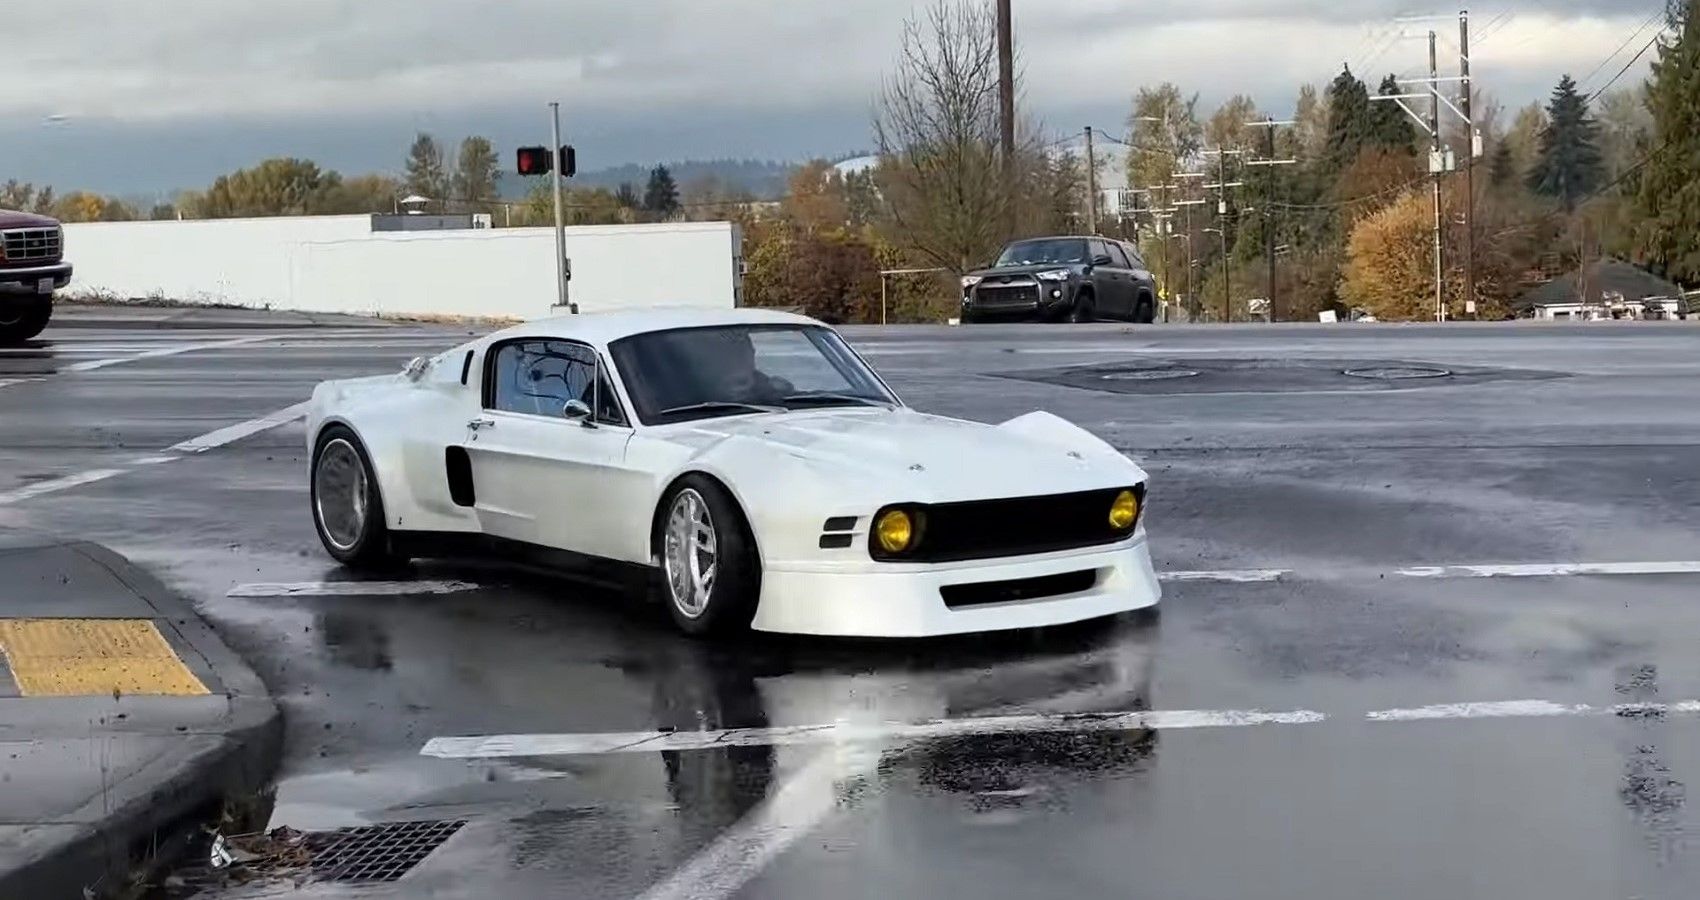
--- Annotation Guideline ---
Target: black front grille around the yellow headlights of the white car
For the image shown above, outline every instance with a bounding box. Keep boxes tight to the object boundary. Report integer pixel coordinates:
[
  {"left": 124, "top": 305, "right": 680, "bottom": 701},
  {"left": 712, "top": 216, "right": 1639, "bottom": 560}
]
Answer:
[{"left": 869, "top": 485, "right": 1146, "bottom": 563}]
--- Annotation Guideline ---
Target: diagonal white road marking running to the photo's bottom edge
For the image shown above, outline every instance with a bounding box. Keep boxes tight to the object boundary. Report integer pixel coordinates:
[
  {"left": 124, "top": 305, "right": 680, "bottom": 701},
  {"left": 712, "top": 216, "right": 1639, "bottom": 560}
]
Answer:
[{"left": 639, "top": 747, "right": 879, "bottom": 900}]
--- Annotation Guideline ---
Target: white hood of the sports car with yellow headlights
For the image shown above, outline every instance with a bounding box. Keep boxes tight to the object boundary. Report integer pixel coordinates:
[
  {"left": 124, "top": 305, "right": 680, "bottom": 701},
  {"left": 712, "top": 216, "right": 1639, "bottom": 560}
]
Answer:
[{"left": 677, "top": 408, "right": 1144, "bottom": 504}]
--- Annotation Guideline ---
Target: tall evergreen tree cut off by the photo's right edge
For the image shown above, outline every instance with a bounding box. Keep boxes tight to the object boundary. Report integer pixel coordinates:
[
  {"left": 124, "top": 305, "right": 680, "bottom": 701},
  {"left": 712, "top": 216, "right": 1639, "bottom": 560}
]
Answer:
[{"left": 1635, "top": 0, "right": 1700, "bottom": 284}]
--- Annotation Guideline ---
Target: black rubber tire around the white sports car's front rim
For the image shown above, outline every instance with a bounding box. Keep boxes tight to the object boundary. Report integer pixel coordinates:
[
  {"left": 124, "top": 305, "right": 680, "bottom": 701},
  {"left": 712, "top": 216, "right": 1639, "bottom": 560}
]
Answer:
[{"left": 655, "top": 475, "right": 762, "bottom": 636}]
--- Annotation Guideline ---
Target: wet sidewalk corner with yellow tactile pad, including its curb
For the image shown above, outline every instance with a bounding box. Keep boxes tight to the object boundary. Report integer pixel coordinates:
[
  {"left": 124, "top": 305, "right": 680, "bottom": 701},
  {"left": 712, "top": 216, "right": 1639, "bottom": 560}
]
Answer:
[{"left": 0, "top": 529, "right": 282, "bottom": 900}]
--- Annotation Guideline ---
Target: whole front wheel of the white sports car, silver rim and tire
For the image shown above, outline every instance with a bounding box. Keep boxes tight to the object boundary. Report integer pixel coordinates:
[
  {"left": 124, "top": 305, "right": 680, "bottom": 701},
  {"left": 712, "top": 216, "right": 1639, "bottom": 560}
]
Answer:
[{"left": 656, "top": 475, "right": 762, "bottom": 635}]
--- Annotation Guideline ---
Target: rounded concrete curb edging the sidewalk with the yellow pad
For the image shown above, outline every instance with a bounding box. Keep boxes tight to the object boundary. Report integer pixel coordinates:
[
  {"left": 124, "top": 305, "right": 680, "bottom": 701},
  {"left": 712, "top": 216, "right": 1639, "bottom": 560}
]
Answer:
[{"left": 0, "top": 539, "right": 284, "bottom": 900}]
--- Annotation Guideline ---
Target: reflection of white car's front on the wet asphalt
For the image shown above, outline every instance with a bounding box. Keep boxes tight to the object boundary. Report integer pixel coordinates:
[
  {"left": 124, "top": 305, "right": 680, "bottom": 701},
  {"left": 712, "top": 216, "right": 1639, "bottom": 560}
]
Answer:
[{"left": 626, "top": 612, "right": 1158, "bottom": 842}]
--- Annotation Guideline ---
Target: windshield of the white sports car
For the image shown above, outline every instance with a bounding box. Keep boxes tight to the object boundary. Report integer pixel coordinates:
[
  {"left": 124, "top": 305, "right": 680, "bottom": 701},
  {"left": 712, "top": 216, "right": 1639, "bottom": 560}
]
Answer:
[{"left": 609, "top": 325, "right": 898, "bottom": 425}]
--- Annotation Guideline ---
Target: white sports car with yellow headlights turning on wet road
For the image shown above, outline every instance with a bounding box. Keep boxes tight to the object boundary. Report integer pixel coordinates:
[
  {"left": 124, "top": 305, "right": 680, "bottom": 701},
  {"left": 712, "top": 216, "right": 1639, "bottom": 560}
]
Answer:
[{"left": 308, "top": 310, "right": 1161, "bottom": 636}]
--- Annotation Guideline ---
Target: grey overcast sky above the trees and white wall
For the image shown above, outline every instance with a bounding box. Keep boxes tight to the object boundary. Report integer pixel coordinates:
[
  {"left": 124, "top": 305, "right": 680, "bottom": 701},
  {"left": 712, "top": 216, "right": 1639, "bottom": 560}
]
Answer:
[{"left": 0, "top": 0, "right": 1663, "bottom": 192}]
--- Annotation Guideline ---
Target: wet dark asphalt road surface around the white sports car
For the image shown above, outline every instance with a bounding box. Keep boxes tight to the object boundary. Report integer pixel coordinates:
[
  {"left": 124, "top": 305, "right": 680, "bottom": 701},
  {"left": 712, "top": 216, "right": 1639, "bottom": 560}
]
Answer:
[{"left": 0, "top": 325, "right": 1700, "bottom": 900}]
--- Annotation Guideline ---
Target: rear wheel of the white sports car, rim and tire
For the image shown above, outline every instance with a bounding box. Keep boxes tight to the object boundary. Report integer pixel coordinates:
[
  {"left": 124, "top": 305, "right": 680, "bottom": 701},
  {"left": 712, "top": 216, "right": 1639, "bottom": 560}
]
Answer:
[{"left": 309, "top": 425, "right": 400, "bottom": 568}]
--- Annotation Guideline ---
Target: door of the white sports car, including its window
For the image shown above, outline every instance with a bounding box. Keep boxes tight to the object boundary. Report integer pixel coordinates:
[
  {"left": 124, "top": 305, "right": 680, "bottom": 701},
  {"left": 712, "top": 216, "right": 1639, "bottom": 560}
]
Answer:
[{"left": 464, "top": 339, "right": 648, "bottom": 558}]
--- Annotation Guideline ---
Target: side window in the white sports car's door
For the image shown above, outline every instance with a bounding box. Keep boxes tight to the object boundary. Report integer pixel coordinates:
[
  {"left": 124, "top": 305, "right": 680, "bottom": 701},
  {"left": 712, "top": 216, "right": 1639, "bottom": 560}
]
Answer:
[{"left": 485, "top": 340, "right": 626, "bottom": 425}]
